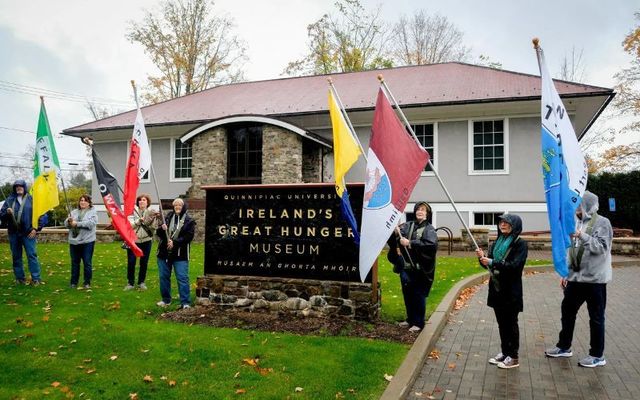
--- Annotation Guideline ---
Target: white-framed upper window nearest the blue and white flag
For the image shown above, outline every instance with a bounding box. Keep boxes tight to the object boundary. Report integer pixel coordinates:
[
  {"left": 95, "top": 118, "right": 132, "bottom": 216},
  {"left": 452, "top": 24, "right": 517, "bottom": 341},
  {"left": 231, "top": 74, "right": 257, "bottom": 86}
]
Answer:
[{"left": 469, "top": 119, "right": 509, "bottom": 173}]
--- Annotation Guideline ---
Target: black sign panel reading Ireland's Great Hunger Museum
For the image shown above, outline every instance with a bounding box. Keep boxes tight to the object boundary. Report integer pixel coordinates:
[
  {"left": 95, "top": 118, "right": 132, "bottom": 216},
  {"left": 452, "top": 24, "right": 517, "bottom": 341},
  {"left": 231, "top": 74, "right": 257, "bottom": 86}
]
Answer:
[{"left": 204, "top": 184, "right": 364, "bottom": 282}]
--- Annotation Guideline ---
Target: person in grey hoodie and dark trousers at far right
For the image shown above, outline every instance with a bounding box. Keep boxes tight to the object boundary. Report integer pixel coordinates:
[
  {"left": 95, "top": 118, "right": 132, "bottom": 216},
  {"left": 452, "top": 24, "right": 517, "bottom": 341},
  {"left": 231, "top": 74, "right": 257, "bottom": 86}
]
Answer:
[{"left": 545, "top": 191, "right": 613, "bottom": 368}]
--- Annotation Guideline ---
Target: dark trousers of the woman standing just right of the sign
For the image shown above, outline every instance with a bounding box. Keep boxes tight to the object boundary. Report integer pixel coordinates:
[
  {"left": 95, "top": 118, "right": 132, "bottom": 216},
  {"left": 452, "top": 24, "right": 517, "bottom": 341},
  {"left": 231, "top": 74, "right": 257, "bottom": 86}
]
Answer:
[{"left": 400, "top": 270, "right": 434, "bottom": 329}]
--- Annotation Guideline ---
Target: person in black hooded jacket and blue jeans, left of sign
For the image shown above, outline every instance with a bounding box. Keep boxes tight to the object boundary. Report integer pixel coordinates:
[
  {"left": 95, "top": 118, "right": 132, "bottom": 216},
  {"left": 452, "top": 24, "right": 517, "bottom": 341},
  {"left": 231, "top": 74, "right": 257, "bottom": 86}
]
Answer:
[{"left": 156, "top": 198, "right": 196, "bottom": 309}]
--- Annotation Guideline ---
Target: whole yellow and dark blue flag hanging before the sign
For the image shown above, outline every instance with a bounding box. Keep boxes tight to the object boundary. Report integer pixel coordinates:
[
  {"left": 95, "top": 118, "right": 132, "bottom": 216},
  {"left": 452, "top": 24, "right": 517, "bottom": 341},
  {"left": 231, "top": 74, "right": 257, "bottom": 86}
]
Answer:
[{"left": 329, "top": 89, "right": 362, "bottom": 244}]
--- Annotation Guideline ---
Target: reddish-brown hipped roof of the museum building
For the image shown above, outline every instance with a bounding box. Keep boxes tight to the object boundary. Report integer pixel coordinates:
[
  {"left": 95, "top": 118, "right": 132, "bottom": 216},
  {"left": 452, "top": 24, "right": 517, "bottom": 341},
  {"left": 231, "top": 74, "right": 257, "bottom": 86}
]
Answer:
[{"left": 64, "top": 62, "right": 613, "bottom": 134}]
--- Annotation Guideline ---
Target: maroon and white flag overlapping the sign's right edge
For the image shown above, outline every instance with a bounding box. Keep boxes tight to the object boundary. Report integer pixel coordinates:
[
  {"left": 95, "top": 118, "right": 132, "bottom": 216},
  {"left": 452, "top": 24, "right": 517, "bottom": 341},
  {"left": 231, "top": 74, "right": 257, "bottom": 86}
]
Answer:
[{"left": 360, "top": 88, "right": 429, "bottom": 282}]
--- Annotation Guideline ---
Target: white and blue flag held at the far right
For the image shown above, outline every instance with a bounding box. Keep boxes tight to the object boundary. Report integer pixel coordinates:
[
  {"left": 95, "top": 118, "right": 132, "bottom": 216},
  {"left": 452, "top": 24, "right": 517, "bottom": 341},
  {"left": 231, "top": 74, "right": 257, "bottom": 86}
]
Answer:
[{"left": 539, "top": 49, "right": 588, "bottom": 278}]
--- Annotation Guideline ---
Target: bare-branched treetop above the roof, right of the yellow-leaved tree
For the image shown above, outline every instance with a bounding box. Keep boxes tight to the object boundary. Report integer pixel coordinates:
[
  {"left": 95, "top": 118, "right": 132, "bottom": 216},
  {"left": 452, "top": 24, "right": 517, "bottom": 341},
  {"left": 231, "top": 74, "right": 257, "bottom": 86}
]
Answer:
[{"left": 392, "top": 10, "right": 471, "bottom": 65}]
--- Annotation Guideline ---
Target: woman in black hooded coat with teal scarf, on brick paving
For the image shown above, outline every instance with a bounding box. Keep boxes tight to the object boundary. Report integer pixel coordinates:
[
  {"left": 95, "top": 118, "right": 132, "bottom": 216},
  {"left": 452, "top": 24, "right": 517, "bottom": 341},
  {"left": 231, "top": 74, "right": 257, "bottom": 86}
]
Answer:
[{"left": 476, "top": 214, "right": 528, "bottom": 368}]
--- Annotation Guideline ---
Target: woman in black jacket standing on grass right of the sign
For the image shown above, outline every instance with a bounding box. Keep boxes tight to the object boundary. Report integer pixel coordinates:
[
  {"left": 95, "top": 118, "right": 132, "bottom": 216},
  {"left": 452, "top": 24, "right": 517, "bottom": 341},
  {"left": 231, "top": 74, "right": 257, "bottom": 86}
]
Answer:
[{"left": 387, "top": 201, "right": 438, "bottom": 332}]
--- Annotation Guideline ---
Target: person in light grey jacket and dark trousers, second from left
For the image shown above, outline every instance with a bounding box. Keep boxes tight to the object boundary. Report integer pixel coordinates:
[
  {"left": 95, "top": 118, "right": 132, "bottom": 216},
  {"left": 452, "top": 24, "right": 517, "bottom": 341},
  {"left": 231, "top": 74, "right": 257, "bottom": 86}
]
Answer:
[{"left": 64, "top": 194, "right": 98, "bottom": 289}]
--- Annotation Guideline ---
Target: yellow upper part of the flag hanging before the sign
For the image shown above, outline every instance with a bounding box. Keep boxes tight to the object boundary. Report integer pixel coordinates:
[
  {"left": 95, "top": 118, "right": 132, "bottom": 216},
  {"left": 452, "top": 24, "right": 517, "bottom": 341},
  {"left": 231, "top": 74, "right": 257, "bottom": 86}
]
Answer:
[{"left": 329, "top": 90, "right": 362, "bottom": 197}]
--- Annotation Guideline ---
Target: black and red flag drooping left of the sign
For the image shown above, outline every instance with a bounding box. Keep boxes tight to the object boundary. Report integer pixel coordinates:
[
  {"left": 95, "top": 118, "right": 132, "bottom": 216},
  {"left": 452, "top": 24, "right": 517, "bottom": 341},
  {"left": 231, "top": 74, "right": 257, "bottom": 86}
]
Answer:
[{"left": 91, "top": 149, "right": 142, "bottom": 257}]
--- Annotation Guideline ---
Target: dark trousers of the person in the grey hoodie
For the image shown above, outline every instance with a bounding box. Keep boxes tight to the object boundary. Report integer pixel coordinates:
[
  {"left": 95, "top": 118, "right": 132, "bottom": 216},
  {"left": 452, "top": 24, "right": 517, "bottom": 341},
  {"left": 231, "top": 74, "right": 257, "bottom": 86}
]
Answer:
[{"left": 556, "top": 282, "right": 607, "bottom": 358}]
